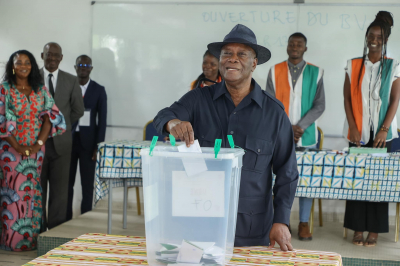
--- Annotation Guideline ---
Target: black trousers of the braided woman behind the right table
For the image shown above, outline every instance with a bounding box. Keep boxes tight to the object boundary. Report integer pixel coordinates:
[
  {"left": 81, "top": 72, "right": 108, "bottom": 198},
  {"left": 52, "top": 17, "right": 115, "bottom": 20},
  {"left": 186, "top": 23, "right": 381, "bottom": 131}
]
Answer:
[{"left": 344, "top": 132, "right": 392, "bottom": 233}]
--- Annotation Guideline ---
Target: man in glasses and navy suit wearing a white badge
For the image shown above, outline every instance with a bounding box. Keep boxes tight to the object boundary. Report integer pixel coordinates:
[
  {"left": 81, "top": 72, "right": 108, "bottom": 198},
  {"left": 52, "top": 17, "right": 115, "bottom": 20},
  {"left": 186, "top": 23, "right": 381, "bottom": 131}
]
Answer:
[{"left": 67, "top": 55, "right": 107, "bottom": 220}]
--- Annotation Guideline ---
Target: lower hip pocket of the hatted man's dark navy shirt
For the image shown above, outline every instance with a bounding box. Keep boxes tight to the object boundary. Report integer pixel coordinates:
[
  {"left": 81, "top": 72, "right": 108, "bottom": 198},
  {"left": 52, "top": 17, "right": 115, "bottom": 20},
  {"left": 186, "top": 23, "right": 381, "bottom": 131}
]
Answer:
[{"left": 236, "top": 198, "right": 267, "bottom": 238}]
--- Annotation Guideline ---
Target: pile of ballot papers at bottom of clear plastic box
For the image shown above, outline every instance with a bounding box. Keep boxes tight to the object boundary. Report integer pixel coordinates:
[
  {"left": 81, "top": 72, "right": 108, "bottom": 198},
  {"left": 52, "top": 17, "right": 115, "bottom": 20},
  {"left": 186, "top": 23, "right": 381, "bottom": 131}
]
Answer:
[{"left": 156, "top": 240, "right": 225, "bottom": 266}]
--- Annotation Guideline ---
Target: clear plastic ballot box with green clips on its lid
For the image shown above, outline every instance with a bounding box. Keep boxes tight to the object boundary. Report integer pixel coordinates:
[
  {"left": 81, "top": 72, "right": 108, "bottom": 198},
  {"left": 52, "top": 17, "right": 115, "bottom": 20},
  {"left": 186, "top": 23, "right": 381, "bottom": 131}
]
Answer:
[{"left": 141, "top": 146, "right": 244, "bottom": 265}]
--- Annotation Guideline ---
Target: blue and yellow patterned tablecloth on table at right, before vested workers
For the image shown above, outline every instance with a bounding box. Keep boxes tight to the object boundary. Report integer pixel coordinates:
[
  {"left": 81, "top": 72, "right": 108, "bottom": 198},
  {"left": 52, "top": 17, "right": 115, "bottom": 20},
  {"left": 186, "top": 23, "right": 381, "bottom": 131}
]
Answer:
[{"left": 296, "top": 152, "right": 400, "bottom": 202}]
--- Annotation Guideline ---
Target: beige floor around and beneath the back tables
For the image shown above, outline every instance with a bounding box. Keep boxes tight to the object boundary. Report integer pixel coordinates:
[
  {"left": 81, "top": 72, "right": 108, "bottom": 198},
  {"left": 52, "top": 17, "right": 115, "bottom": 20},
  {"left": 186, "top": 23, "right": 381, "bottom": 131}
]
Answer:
[{"left": 0, "top": 206, "right": 400, "bottom": 266}]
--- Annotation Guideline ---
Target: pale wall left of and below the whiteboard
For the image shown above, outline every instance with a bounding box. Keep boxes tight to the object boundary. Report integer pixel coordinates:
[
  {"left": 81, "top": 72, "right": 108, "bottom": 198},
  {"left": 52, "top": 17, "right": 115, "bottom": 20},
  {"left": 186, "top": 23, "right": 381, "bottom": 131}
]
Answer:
[{"left": 0, "top": 0, "right": 398, "bottom": 219}]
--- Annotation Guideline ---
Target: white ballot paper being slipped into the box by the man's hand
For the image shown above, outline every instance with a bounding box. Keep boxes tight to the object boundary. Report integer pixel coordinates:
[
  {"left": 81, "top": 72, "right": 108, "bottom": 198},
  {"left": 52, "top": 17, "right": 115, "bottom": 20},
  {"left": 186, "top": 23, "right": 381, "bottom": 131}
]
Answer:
[{"left": 178, "top": 139, "right": 207, "bottom": 176}]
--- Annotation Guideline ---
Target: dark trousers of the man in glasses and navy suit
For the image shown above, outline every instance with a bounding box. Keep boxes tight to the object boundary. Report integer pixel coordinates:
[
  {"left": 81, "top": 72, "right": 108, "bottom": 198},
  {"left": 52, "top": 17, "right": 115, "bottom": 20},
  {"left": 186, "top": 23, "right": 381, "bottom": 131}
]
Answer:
[{"left": 67, "top": 132, "right": 96, "bottom": 220}]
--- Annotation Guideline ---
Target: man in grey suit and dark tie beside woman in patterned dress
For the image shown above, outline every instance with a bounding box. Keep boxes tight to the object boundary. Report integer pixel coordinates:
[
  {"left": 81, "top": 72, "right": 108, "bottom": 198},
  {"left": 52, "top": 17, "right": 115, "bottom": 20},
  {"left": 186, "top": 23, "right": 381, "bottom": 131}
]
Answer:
[{"left": 40, "top": 43, "right": 85, "bottom": 231}]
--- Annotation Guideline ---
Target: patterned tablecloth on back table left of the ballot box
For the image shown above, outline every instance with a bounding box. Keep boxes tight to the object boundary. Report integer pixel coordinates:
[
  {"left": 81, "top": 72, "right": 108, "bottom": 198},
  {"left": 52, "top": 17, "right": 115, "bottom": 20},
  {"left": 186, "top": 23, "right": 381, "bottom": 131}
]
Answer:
[{"left": 95, "top": 140, "right": 170, "bottom": 204}]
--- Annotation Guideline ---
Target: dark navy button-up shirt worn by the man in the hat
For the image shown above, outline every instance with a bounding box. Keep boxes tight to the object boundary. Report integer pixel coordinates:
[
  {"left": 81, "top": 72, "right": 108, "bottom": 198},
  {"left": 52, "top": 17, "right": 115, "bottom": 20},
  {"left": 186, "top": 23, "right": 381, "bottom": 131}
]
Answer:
[{"left": 154, "top": 80, "right": 299, "bottom": 246}]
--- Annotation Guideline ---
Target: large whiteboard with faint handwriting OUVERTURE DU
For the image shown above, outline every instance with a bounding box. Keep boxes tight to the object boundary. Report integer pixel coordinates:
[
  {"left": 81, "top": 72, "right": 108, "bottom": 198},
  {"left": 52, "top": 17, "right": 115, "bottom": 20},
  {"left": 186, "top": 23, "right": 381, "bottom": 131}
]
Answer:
[{"left": 92, "top": 2, "right": 400, "bottom": 135}]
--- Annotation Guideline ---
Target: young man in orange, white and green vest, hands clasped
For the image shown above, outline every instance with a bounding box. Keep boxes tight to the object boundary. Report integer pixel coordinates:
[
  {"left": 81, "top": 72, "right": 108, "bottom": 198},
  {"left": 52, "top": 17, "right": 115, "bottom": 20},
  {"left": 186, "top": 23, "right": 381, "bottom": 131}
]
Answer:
[{"left": 266, "top": 32, "right": 325, "bottom": 240}]
